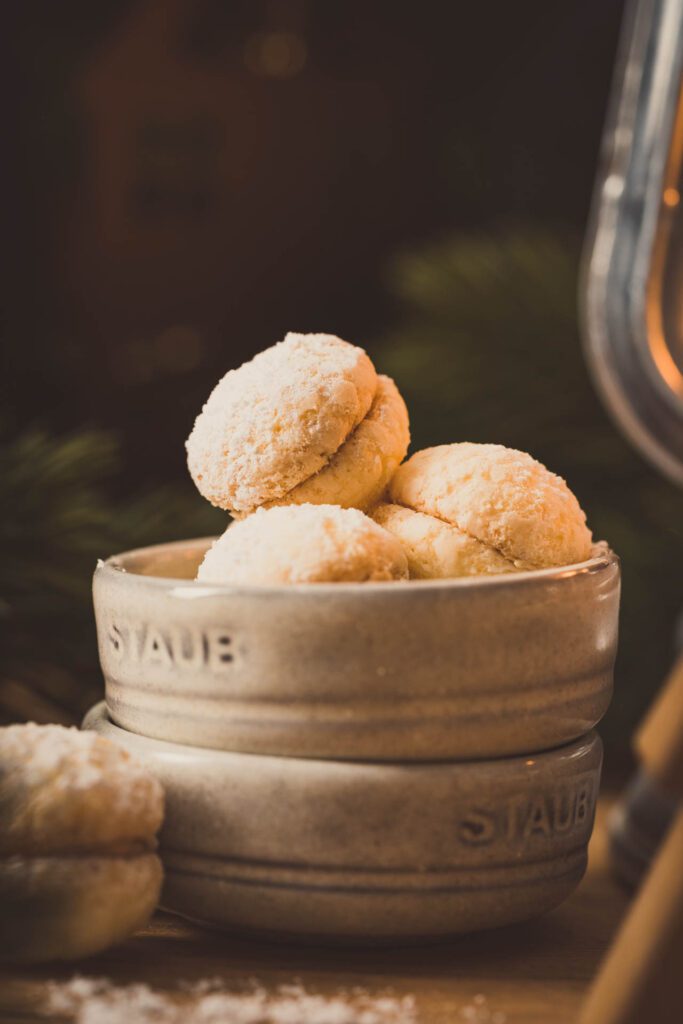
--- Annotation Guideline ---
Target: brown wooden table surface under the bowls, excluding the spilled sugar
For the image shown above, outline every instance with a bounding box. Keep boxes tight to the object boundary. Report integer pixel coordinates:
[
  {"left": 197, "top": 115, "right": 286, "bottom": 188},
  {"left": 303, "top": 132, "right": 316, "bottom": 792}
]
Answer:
[{"left": 0, "top": 800, "right": 628, "bottom": 1024}]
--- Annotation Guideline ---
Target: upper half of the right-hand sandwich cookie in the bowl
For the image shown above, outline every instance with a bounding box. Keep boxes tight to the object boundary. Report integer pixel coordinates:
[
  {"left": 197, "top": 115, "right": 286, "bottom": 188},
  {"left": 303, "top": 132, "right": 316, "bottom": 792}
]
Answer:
[{"left": 389, "top": 442, "right": 591, "bottom": 568}]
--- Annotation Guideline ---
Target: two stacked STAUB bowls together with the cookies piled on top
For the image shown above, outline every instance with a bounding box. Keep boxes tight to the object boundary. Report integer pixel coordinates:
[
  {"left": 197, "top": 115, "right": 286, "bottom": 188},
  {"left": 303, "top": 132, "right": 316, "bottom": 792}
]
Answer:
[{"left": 87, "top": 334, "right": 618, "bottom": 941}]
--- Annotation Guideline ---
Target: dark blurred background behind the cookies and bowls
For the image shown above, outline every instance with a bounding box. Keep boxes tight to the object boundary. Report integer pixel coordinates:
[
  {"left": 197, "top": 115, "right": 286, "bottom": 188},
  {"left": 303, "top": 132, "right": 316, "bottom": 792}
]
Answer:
[{"left": 0, "top": 0, "right": 683, "bottom": 759}]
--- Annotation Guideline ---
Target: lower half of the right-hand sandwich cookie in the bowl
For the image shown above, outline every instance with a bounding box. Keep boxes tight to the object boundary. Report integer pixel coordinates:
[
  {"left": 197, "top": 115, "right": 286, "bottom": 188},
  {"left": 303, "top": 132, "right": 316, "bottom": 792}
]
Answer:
[{"left": 371, "top": 504, "right": 518, "bottom": 580}]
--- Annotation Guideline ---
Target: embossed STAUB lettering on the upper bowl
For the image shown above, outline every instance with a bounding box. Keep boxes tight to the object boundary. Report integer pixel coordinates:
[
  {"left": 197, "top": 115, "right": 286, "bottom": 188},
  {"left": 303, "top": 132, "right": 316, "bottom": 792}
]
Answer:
[{"left": 105, "top": 621, "right": 233, "bottom": 672}]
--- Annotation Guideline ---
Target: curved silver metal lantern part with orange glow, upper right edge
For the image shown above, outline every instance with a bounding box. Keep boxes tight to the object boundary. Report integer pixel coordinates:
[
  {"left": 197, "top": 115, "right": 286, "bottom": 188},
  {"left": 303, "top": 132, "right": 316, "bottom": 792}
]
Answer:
[{"left": 582, "top": 0, "right": 683, "bottom": 484}]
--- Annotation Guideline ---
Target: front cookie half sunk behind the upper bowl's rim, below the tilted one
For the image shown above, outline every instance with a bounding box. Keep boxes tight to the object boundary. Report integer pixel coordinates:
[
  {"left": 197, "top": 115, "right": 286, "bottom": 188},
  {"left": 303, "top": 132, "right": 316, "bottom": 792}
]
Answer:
[{"left": 197, "top": 505, "right": 408, "bottom": 584}]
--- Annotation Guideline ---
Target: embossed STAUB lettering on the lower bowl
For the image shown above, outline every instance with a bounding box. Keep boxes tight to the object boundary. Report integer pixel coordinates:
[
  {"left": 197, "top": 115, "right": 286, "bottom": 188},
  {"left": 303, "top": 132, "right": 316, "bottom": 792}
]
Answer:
[{"left": 458, "top": 776, "right": 596, "bottom": 846}]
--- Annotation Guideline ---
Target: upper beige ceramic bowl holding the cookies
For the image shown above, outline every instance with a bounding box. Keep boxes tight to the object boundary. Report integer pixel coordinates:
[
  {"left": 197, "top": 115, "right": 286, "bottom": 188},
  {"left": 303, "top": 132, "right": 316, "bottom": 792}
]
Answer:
[{"left": 94, "top": 541, "right": 620, "bottom": 761}]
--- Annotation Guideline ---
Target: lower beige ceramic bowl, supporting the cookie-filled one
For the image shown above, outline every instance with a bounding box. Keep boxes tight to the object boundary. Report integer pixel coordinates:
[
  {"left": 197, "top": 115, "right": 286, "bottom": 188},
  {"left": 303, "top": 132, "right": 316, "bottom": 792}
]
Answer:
[{"left": 84, "top": 703, "right": 601, "bottom": 942}]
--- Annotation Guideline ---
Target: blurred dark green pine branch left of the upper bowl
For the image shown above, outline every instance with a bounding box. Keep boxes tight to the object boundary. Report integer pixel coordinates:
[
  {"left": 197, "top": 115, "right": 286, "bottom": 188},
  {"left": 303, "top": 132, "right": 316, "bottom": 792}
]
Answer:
[{"left": 0, "top": 430, "right": 226, "bottom": 721}]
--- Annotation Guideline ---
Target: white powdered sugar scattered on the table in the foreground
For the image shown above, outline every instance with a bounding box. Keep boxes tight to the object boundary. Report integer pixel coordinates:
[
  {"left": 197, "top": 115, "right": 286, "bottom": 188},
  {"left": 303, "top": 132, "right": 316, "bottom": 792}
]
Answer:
[{"left": 44, "top": 976, "right": 417, "bottom": 1024}]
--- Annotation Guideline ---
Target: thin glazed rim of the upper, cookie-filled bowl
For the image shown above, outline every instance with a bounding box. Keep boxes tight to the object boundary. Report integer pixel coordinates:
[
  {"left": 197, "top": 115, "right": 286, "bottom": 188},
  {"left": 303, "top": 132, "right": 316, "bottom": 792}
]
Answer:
[{"left": 94, "top": 537, "right": 620, "bottom": 598}]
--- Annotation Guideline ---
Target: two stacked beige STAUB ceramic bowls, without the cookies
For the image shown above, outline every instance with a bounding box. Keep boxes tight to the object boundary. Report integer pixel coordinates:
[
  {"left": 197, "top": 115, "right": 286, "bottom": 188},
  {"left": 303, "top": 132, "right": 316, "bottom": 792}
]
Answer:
[{"left": 86, "top": 542, "right": 620, "bottom": 941}]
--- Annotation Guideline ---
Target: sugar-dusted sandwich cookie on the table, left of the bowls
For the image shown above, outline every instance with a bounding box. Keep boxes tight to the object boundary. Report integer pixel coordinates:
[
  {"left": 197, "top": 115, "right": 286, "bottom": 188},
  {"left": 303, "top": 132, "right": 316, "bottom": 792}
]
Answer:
[{"left": 0, "top": 723, "right": 164, "bottom": 961}]
